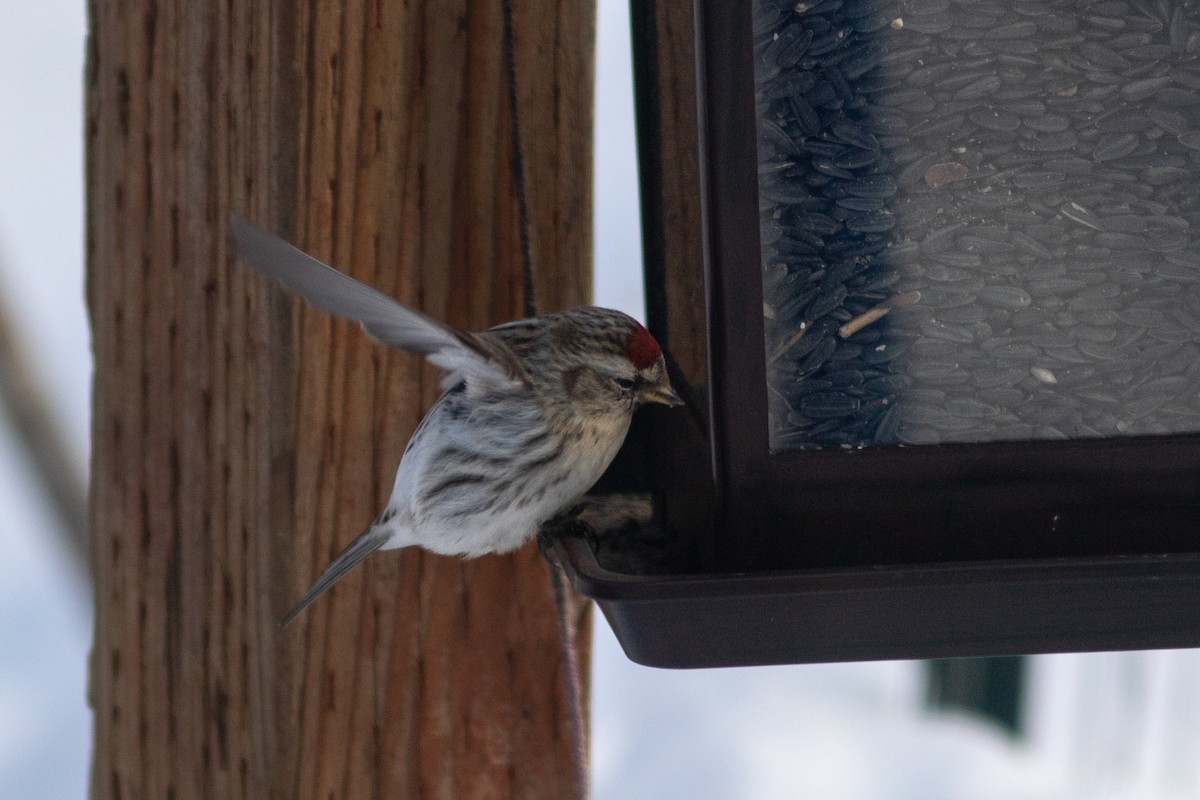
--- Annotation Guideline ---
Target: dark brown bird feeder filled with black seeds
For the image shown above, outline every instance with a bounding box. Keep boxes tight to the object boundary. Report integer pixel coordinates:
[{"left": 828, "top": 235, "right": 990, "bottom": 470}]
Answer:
[{"left": 547, "top": 0, "right": 1200, "bottom": 667}]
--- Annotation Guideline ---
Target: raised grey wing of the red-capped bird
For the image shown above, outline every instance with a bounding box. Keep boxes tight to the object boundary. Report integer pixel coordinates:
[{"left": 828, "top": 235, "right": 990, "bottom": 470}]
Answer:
[{"left": 229, "top": 216, "right": 526, "bottom": 389}]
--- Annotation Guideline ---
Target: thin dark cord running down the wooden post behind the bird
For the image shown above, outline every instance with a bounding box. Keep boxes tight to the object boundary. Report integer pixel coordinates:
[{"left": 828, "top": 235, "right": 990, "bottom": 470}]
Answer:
[{"left": 502, "top": 0, "right": 590, "bottom": 800}]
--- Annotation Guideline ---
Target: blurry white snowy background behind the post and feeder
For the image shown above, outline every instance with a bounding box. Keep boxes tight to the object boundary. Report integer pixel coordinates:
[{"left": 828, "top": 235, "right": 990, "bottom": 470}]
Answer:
[{"left": 7, "top": 0, "right": 1200, "bottom": 800}]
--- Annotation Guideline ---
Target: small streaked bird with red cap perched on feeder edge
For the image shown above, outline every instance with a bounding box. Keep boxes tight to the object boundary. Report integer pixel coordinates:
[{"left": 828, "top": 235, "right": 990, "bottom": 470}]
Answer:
[{"left": 230, "top": 217, "right": 682, "bottom": 625}]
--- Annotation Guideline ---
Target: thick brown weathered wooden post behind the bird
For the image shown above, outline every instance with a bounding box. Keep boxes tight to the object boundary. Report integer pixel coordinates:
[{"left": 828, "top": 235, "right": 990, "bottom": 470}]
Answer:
[{"left": 86, "top": 0, "right": 594, "bottom": 800}]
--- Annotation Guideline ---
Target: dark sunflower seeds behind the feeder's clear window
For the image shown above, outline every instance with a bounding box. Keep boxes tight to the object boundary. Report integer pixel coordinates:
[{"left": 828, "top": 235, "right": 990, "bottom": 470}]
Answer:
[{"left": 754, "top": 0, "right": 1200, "bottom": 449}]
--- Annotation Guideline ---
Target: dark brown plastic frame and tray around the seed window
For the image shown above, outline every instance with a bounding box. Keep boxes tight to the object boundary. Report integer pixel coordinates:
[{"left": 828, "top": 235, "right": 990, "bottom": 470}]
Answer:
[{"left": 554, "top": 0, "right": 1200, "bottom": 667}]
